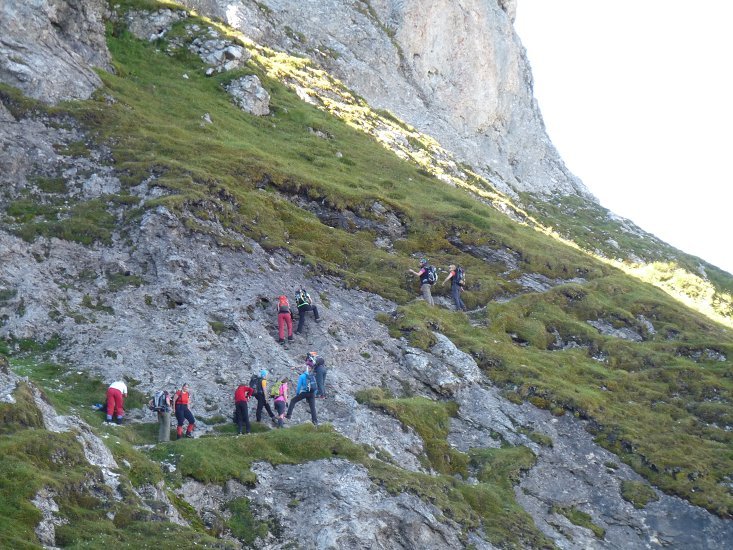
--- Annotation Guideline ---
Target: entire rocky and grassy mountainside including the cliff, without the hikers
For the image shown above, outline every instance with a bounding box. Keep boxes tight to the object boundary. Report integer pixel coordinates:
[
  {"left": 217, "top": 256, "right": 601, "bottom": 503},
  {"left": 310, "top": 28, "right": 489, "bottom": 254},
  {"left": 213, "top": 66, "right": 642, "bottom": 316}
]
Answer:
[{"left": 0, "top": 0, "right": 733, "bottom": 548}]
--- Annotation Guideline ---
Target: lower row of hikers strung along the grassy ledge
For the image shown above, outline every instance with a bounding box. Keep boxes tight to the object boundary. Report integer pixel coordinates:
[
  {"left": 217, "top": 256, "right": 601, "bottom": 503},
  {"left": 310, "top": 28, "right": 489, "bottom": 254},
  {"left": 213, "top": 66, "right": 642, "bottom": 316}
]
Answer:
[{"left": 106, "top": 351, "right": 327, "bottom": 441}]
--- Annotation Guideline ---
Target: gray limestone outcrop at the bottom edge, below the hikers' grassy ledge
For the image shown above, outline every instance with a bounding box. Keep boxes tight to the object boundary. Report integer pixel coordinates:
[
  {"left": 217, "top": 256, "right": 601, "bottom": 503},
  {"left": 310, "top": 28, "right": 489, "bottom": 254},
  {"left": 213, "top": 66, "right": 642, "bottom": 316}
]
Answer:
[{"left": 244, "top": 459, "right": 480, "bottom": 550}]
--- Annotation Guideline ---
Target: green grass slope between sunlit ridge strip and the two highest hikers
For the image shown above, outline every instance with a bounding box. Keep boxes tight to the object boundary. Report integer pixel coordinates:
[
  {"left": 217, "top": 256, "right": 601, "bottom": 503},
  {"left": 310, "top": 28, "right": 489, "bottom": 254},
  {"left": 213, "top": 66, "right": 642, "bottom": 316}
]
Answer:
[{"left": 93, "top": 3, "right": 612, "bottom": 302}]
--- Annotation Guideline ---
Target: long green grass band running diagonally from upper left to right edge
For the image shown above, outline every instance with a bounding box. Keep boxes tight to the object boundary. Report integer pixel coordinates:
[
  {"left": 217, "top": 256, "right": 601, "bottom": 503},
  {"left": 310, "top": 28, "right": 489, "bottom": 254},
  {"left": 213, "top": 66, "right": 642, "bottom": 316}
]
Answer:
[{"left": 0, "top": 0, "right": 733, "bottom": 536}]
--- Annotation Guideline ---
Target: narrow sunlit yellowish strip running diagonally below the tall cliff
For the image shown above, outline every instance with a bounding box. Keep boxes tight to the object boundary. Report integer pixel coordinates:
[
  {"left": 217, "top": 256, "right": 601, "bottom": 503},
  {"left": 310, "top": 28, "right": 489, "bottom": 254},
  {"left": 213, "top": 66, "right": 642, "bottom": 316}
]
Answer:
[{"left": 190, "top": 14, "right": 733, "bottom": 327}]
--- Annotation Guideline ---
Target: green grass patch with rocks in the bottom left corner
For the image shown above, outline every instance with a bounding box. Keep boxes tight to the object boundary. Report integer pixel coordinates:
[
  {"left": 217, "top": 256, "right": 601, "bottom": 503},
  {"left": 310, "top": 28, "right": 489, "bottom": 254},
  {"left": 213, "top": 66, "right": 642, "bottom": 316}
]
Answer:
[{"left": 0, "top": 384, "right": 222, "bottom": 548}]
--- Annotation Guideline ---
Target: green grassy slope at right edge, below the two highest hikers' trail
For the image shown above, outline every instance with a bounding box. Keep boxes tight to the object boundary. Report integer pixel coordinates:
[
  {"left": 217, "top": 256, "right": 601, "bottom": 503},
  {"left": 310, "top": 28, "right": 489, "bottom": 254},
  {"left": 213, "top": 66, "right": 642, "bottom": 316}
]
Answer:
[{"left": 380, "top": 296, "right": 733, "bottom": 517}]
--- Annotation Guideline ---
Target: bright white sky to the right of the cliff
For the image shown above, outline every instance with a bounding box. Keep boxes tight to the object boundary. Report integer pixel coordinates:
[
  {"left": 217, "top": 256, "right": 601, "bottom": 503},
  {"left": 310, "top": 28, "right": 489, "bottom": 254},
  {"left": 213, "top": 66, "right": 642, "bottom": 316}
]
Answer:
[{"left": 515, "top": 0, "right": 733, "bottom": 273}]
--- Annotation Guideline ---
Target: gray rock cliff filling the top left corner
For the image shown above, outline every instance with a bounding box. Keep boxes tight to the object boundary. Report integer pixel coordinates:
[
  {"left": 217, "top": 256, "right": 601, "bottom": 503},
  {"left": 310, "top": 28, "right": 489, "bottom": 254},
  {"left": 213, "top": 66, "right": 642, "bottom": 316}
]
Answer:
[{"left": 0, "top": 0, "right": 110, "bottom": 103}]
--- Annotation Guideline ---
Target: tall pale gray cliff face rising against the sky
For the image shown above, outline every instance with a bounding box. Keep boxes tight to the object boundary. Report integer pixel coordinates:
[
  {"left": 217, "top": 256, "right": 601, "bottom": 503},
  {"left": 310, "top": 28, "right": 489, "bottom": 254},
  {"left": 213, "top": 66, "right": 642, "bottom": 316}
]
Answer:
[{"left": 184, "top": 0, "right": 590, "bottom": 197}]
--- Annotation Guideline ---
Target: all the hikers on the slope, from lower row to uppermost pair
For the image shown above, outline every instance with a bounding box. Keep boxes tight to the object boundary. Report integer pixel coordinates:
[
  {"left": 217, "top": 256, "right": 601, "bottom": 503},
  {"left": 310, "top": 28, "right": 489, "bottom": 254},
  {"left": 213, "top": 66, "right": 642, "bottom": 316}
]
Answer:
[{"left": 106, "top": 266, "right": 458, "bottom": 441}]
